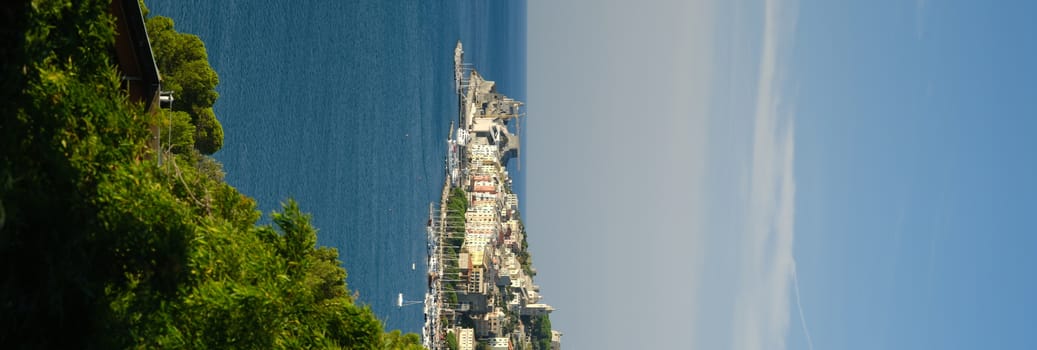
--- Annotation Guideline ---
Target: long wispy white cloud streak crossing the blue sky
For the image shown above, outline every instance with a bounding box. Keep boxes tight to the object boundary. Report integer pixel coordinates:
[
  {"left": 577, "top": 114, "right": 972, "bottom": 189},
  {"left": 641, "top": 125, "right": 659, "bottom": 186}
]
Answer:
[{"left": 732, "top": 0, "right": 806, "bottom": 349}]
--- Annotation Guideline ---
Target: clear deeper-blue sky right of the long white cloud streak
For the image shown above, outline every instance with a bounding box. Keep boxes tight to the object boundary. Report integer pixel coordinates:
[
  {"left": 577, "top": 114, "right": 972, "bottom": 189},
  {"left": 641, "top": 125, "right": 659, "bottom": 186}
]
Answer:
[{"left": 790, "top": 1, "right": 1037, "bottom": 349}]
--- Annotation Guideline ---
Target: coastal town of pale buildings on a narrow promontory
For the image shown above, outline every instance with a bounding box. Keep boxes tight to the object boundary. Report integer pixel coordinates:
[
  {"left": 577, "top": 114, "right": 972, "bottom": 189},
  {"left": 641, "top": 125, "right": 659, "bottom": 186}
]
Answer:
[{"left": 418, "top": 41, "right": 562, "bottom": 350}]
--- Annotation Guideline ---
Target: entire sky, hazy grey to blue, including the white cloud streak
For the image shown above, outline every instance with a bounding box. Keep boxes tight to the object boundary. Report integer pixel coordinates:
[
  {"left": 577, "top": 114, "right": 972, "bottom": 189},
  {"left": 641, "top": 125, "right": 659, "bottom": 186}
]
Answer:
[{"left": 524, "top": 0, "right": 1037, "bottom": 349}]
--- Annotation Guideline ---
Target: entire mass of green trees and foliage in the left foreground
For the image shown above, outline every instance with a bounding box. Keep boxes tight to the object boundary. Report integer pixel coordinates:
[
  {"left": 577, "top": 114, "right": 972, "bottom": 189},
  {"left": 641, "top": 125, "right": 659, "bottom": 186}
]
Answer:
[{"left": 0, "top": 0, "right": 423, "bottom": 350}]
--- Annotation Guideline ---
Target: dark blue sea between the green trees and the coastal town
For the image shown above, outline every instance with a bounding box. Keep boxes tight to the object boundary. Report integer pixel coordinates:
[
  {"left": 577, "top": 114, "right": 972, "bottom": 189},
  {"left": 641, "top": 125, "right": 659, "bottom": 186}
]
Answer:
[{"left": 146, "top": 0, "right": 526, "bottom": 332}]
